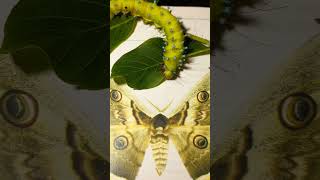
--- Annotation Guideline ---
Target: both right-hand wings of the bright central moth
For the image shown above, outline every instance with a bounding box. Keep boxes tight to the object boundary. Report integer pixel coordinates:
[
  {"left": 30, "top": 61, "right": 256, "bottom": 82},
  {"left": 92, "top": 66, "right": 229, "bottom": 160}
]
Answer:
[{"left": 169, "top": 73, "right": 210, "bottom": 179}]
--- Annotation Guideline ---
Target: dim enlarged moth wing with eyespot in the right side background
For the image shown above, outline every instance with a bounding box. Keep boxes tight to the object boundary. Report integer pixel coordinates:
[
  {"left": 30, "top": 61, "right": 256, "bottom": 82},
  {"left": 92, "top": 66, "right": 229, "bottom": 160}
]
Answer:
[{"left": 211, "top": 34, "right": 320, "bottom": 180}]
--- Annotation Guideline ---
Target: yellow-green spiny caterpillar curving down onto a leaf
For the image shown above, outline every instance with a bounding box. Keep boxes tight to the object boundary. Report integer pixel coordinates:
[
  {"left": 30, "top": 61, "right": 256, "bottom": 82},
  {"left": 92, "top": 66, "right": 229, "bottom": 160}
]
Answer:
[{"left": 110, "top": 0, "right": 185, "bottom": 79}]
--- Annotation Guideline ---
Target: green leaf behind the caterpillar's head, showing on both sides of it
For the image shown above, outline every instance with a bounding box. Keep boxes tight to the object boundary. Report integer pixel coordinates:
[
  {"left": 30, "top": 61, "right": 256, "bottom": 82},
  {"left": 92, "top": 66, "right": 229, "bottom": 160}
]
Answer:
[{"left": 111, "top": 36, "right": 210, "bottom": 89}]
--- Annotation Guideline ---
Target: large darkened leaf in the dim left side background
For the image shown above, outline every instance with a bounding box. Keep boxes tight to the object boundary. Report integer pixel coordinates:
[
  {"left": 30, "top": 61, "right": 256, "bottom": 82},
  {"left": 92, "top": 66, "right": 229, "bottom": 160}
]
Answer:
[{"left": 2, "top": 0, "right": 109, "bottom": 89}]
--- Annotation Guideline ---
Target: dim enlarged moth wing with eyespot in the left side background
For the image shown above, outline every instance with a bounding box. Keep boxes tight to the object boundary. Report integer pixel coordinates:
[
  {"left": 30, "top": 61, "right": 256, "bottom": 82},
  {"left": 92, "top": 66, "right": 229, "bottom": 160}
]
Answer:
[{"left": 0, "top": 54, "right": 109, "bottom": 180}]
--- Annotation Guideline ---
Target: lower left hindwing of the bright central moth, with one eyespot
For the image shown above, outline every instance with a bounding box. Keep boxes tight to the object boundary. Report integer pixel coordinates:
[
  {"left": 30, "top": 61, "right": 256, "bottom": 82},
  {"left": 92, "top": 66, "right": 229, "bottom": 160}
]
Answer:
[{"left": 110, "top": 125, "right": 150, "bottom": 180}]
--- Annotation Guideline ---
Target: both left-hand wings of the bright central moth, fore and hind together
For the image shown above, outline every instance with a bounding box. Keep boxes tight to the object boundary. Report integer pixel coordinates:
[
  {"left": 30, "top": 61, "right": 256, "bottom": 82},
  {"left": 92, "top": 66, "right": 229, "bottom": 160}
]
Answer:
[{"left": 110, "top": 80, "right": 151, "bottom": 180}]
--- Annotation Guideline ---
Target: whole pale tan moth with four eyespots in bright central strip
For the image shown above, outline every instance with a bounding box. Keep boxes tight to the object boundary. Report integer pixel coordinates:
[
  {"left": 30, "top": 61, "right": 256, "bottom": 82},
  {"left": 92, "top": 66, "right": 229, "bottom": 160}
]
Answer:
[{"left": 110, "top": 74, "right": 210, "bottom": 180}]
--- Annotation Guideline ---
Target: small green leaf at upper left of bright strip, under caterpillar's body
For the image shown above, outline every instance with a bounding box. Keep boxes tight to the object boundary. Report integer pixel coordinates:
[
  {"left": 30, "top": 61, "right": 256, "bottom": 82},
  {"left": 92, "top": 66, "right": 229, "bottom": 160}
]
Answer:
[{"left": 110, "top": 16, "right": 137, "bottom": 52}]
